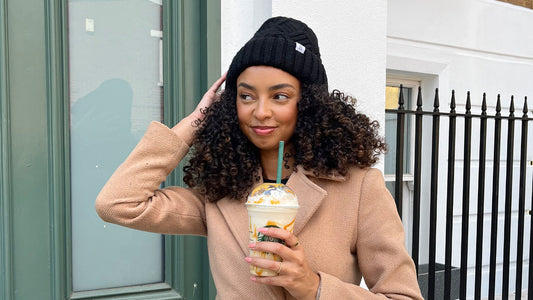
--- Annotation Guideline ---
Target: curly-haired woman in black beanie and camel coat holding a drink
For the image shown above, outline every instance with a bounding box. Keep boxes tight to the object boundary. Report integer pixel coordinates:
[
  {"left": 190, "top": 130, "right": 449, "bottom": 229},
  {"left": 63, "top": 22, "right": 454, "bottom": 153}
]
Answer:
[{"left": 96, "top": 17, "right": 422, "bottom": 299}]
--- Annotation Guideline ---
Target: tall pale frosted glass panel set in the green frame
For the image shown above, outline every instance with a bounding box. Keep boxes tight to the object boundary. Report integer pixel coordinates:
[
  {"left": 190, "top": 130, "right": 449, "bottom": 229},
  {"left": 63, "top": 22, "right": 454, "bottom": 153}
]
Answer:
[{"left": 68, "top": 0, "right": 163, "bottom": 291}]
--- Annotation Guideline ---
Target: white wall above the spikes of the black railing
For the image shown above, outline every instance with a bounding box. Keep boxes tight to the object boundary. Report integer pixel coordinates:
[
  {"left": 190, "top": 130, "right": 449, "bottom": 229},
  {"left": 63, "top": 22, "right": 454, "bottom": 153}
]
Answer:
[{"left": 387, "top": 0, "right": 533, "bottom": 105}]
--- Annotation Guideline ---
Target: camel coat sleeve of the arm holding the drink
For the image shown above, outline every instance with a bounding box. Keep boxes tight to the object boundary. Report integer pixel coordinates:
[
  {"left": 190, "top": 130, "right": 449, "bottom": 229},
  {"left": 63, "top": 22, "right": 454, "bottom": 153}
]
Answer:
[{"left": 314, "top": 169, "right": 423, "bottom": 300}]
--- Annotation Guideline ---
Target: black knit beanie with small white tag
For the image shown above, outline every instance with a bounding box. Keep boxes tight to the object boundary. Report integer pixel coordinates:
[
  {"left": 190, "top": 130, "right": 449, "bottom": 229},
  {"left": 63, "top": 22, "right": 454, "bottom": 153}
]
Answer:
[{"left": 226, "top": 17, "right": 327, "bottom": 90}]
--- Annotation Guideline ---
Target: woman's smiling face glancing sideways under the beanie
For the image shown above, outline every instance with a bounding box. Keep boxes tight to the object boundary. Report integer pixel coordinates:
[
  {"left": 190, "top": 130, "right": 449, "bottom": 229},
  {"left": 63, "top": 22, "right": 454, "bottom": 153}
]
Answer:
[{"left": 237, "top": 66, "right": 301, "bottom": 150}]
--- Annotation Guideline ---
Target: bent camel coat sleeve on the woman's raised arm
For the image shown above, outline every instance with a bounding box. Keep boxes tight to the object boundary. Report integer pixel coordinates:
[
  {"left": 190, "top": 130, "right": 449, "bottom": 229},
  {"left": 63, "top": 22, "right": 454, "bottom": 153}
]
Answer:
[{"left": 95, "top": 122, "right": 207, "bottom": 236}]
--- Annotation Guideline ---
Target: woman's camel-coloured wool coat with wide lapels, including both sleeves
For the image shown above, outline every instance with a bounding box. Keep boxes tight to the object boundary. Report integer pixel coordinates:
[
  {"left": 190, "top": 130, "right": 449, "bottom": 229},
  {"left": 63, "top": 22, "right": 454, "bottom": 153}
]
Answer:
[{"left": 96, "top": 122, "right": 422, "bottom": 300}]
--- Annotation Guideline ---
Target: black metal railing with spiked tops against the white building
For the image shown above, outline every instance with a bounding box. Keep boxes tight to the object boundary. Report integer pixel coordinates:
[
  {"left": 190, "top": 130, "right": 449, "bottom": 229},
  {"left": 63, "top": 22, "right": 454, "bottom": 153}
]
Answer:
[{"left": 386, "top": 86, "right": 533, "bottom": 300}]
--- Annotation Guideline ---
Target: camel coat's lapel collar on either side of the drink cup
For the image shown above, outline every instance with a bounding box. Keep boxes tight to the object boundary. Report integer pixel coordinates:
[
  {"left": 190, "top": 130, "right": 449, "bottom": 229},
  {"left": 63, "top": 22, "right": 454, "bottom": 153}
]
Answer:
[{"left": 216, "top": 166, "right": 345, "bottom": 255}]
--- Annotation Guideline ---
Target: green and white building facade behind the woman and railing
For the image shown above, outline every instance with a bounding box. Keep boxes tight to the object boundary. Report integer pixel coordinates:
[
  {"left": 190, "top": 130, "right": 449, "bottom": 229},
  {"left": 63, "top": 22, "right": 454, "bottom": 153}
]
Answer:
[{"left": 0, "top": 0, "right": 533, "bottom": 300}]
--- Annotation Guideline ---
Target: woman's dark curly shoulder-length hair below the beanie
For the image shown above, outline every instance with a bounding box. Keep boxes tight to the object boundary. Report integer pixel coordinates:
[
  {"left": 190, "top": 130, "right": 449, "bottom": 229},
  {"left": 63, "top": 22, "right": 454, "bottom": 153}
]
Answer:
[{"left": 183, "top": 84, "right": 387, "bottom": 202}]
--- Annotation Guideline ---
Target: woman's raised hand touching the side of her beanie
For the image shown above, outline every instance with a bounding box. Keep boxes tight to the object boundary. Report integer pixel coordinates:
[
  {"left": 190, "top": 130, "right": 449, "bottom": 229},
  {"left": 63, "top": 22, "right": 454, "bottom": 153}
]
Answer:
[{"left": 172, "top": 72, "right": 227, "bottom": 145}]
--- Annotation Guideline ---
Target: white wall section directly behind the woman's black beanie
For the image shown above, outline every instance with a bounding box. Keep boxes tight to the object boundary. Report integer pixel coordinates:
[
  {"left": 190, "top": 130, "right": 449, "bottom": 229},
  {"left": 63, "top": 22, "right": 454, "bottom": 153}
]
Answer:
[{"left": 221, "top": 0, "right": 387, "bottom": 131}]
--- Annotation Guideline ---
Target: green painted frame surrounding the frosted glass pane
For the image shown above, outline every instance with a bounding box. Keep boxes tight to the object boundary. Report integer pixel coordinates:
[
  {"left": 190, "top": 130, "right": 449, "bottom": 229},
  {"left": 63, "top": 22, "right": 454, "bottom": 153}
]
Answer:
[{"left": 0, "top": 0, "right": 220, "bottom": 300}]
